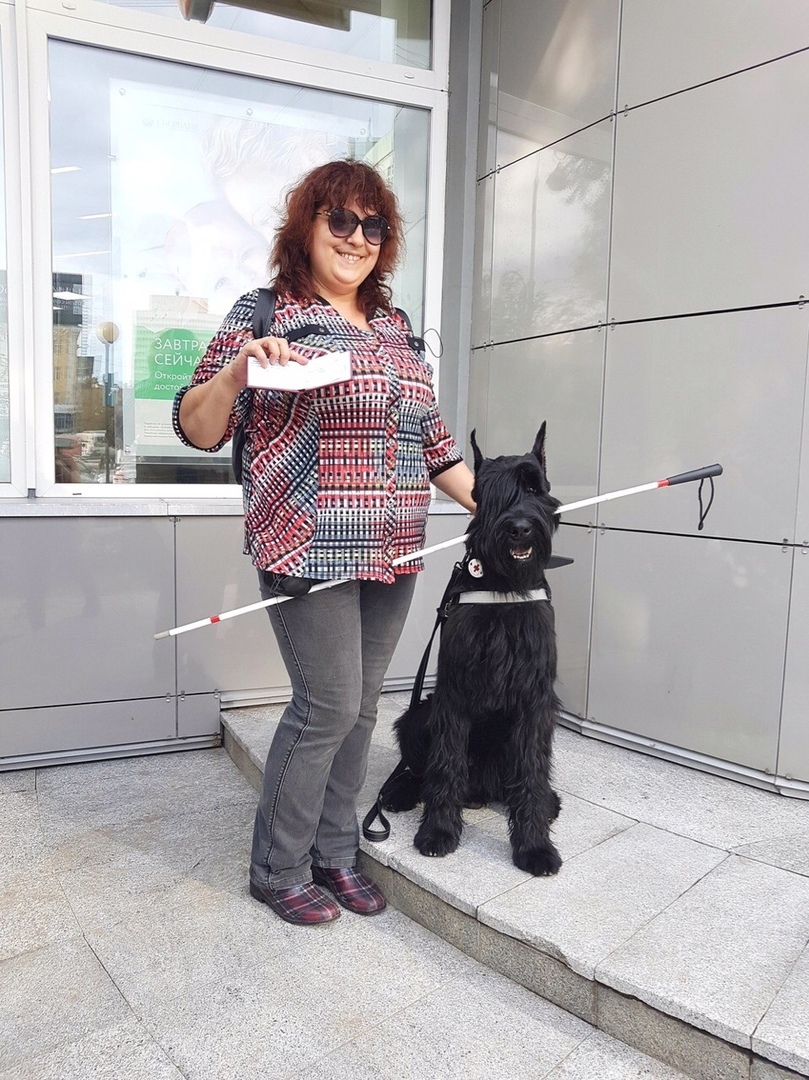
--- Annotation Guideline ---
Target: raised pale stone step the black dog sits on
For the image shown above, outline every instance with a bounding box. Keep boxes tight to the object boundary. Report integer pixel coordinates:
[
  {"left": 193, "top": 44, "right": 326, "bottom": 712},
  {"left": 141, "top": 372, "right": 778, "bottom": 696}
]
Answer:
[{"left": 223, "top": 693, "right": 809, "bottom": 1080}]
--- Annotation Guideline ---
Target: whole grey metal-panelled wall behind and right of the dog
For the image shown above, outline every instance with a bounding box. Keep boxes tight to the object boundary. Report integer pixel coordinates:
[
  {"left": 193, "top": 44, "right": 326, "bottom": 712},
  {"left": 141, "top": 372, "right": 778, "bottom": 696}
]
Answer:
[{"left": 469, "top": 0, "right": 809, "bottom": 779}]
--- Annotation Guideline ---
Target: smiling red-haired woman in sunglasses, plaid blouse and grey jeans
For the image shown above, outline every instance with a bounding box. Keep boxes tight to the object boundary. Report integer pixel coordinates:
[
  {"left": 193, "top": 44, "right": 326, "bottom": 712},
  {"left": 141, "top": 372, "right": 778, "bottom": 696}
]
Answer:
[{"left": 174, "top": 161, "right": 474, "bottom": 924}]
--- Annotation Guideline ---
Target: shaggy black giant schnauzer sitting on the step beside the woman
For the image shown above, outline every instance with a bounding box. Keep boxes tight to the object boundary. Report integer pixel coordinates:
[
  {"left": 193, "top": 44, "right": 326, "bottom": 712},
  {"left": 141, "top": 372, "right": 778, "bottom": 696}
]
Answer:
[{"left": 383, "top": 423, "right": 562, "bottom": 875}]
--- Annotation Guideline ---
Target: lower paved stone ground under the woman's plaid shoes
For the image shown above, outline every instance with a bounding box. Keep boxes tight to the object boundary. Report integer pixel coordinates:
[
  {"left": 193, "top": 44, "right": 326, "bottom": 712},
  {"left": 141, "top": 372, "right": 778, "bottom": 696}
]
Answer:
[{"left": 0, "top": 750, "right": 695, "bottom": 1080}]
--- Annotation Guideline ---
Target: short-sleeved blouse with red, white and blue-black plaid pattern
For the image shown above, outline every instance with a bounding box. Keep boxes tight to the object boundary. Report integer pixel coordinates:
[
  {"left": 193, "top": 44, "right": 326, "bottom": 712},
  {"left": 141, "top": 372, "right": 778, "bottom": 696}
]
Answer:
[{"left": 174, "top": 291, "right": 462, "bottom": 583}]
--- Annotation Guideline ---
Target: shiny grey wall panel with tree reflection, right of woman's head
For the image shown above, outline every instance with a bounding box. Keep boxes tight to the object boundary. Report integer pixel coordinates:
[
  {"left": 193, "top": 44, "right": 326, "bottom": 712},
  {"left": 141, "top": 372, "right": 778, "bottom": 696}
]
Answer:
[{"left": 491, "top": 121, "right": 612, "bottom": 341}]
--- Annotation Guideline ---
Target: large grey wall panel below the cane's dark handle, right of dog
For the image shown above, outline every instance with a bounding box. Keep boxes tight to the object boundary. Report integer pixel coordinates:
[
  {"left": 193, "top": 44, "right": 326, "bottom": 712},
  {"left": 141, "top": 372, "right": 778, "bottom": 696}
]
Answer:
[{"left": 589, "top": 531, "right": 792, "bottom": 772}]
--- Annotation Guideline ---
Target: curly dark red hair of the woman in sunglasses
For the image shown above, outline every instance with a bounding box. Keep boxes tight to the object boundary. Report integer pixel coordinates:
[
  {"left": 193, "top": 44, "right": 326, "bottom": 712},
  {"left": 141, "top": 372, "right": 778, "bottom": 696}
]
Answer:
[{"left": 269, "top": 159, "right": 403, "bottom": 319}]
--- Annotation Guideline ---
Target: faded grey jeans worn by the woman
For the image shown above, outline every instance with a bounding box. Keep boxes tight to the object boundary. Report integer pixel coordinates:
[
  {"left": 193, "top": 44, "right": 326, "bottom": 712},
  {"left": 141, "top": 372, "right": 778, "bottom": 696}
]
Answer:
[{"left": 251, "top": 573, "right": 416, "bottom": 889}]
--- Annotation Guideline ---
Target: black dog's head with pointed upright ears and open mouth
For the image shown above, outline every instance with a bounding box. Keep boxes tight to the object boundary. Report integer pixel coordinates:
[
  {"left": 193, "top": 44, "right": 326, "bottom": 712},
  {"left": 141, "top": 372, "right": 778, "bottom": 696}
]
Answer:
[{"left": 467, "top": 422, "right": 561, "bottom": 592}]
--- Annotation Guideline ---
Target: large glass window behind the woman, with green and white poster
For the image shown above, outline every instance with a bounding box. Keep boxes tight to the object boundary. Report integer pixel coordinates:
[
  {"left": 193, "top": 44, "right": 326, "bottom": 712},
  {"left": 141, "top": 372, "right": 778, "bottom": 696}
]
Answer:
[{"left": 51, "top": 41, "right": 429, "bottom": 484}]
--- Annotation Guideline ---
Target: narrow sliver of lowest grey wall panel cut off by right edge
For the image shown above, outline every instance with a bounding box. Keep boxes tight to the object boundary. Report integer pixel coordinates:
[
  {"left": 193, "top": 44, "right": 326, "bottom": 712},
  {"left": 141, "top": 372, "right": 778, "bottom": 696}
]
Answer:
[{"left": 778, "top": 548, "right": 809, "bottom": 782}]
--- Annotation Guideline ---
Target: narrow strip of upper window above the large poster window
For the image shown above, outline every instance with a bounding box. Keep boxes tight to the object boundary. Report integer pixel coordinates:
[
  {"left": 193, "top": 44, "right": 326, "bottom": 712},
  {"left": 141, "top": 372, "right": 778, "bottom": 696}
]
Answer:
[{"left": 92, "top": 0, "right": 432, "bottom": 68}]
